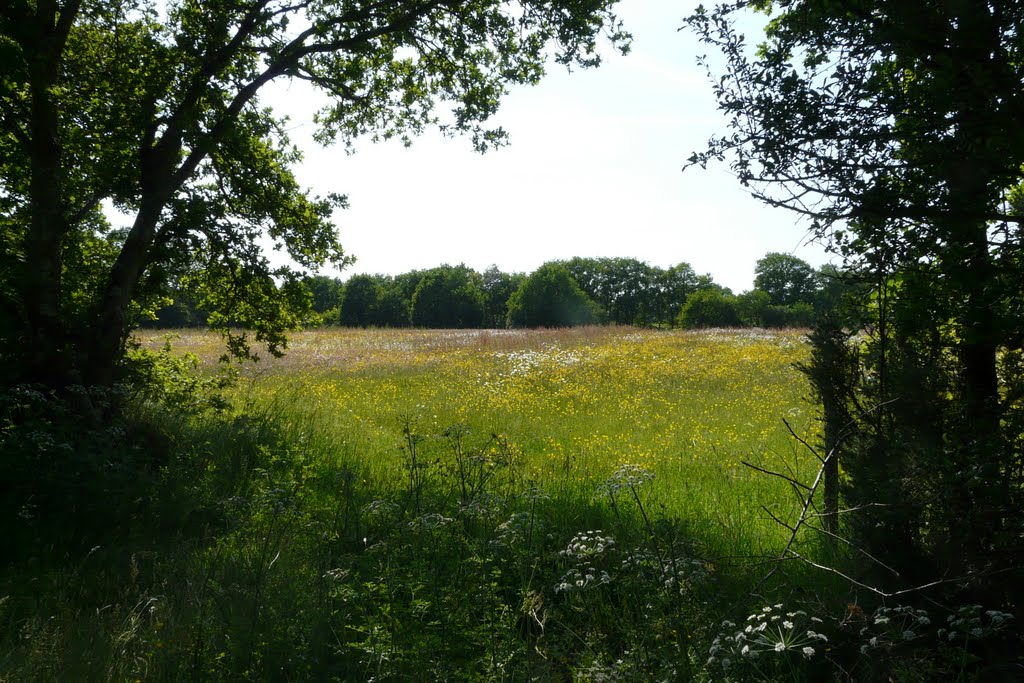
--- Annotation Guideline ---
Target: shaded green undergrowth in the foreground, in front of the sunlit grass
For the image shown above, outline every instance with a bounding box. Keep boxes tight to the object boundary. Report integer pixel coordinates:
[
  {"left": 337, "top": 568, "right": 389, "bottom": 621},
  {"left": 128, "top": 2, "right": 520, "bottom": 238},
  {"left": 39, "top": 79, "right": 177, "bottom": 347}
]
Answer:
[{"left": 0, "top": 393, "right": 714, "bottom": 680}]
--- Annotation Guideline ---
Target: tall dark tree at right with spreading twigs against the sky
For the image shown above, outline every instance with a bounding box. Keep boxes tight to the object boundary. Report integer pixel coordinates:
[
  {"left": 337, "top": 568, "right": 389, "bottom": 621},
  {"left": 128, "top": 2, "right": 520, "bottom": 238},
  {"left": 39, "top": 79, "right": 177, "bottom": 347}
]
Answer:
[{"left": 688, "top": 0, "right": 1024, "bottom": 591}]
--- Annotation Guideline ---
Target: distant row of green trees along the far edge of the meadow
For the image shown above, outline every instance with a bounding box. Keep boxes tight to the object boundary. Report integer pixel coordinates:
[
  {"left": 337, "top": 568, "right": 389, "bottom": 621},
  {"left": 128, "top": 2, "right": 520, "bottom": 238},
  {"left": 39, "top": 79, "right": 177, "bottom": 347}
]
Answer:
[{"left": 147, "top": 253, "right": 846, "bottom": 329}]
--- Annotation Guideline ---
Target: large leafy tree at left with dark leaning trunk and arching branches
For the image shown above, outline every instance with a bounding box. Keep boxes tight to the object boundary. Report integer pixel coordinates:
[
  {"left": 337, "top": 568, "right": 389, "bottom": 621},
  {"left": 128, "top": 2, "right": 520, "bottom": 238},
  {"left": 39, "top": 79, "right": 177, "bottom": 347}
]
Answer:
[{"left": 0, "top": 0, "right": 627, "bottom": 386}]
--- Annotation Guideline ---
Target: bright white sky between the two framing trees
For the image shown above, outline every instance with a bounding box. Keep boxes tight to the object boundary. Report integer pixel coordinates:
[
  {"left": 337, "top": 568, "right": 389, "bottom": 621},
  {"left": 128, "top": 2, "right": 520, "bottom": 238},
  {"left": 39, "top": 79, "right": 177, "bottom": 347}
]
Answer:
[{"left": 262, "top": 0, "right": 827, "bottom": 293}]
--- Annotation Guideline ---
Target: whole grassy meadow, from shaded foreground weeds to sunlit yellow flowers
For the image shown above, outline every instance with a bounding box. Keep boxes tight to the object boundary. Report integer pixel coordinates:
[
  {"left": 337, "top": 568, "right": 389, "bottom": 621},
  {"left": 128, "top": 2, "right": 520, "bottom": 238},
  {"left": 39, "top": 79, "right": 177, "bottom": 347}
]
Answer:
[{"left": 0, "top": 328, "right": 856, "bottom": 681}]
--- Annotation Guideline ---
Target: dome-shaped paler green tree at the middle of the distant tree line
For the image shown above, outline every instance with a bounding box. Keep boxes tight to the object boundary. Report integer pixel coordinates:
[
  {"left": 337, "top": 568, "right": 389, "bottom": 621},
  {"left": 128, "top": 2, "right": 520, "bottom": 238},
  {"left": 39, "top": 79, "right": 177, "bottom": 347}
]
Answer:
[{"left": 508, "top": 262, "right": 600, "bottom": 328}]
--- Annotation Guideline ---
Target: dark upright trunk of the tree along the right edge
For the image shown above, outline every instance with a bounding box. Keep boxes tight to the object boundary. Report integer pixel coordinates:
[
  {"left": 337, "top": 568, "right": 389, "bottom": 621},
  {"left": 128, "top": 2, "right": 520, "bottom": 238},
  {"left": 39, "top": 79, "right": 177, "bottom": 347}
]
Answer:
[{"left": 939, "top": 2, "right": 1010, "bottom": 569}]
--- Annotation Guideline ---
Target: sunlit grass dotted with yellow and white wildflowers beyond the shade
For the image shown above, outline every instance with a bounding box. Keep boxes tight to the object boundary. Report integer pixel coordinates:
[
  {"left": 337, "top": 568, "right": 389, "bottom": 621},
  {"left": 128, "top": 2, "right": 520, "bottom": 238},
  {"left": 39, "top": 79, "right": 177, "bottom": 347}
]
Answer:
[{"left": 146, "top": 328, "right": 817, "bottom": 556}]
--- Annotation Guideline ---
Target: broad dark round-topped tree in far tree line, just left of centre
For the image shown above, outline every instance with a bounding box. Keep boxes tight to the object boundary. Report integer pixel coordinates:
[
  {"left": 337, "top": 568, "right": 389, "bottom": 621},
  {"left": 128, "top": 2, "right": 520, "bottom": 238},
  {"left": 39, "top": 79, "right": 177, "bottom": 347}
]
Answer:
[{"left": 412, "top": 265, "right": 486, "bottom": 329}]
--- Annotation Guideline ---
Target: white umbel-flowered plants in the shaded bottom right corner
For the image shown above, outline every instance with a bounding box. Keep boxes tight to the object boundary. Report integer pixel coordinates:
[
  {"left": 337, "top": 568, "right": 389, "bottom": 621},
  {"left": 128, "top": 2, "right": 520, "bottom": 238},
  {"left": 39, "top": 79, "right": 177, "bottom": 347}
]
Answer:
[{"left": 708, "top": 602, "right": 1019, "bottom": 681}]
